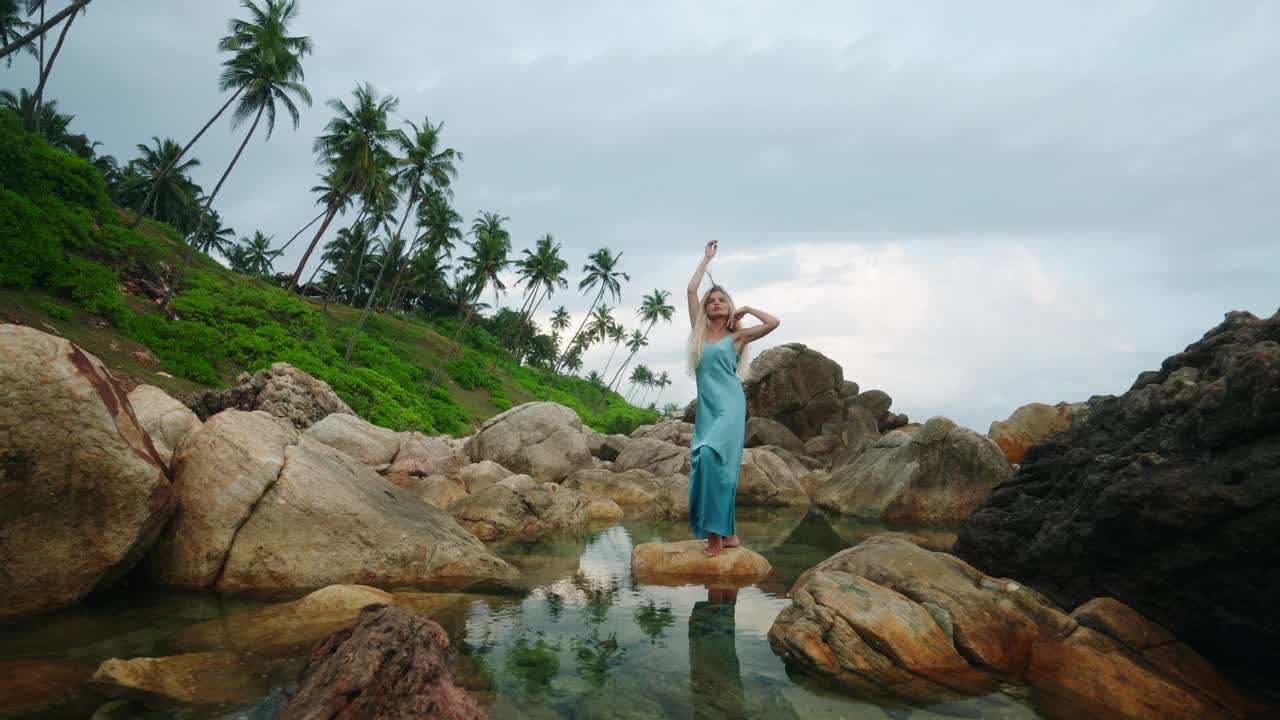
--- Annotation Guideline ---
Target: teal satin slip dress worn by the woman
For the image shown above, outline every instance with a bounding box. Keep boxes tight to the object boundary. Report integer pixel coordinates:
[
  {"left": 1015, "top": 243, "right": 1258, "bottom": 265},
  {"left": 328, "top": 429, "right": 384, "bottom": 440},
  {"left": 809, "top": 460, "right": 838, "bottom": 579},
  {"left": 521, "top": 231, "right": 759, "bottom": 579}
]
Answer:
[{"left": 689, "top": 334, "right": 746, "bottom": 539}]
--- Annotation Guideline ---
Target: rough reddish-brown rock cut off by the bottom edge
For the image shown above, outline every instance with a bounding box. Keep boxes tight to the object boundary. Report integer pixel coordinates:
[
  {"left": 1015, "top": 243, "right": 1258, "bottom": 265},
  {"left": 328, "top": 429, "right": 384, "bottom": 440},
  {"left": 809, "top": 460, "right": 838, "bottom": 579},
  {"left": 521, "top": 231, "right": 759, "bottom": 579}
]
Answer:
[{"left": 280, "top": 605, "right": 488, "bottom": 720}]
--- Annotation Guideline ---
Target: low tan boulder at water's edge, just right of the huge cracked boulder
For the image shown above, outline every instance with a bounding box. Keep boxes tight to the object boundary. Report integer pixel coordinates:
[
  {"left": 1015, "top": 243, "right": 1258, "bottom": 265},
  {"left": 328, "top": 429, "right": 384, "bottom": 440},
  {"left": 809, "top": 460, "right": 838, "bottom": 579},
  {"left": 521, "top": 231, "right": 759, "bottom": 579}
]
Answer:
[{"left": 449, "top": 475, "right": 609, "bottom": 539}]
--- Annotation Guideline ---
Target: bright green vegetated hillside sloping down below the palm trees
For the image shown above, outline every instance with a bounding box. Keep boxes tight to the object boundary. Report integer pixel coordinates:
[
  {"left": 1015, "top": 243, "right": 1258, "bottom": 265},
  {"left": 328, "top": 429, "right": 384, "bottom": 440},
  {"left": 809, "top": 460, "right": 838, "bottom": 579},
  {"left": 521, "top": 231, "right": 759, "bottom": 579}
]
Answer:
[{"left": 0, "top": 106, "right": 657, "bottom": 434}]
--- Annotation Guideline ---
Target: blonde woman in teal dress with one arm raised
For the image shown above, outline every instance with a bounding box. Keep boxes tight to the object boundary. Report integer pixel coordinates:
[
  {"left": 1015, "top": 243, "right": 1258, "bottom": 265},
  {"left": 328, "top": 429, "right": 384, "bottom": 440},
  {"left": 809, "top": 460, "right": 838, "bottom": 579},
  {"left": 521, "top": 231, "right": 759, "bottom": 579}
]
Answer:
[{"left": 689, "top": 240, "right": 778, "bottom": 557}]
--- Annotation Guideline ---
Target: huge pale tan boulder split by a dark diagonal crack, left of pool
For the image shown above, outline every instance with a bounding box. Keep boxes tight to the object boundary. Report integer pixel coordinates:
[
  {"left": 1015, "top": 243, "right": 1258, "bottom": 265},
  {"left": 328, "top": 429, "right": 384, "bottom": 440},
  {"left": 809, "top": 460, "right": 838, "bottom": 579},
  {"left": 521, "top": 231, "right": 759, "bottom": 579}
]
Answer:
[{"left": 147, "top": 410, "right": 511, "bottom": 589}]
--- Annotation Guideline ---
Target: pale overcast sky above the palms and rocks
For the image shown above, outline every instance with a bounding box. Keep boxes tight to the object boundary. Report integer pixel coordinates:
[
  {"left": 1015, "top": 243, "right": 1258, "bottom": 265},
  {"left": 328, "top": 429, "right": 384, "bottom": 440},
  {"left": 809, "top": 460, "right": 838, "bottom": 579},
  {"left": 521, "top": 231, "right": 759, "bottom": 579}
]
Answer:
[{"left": 12, "top": 0, "right": 1280, "bottom": 430}]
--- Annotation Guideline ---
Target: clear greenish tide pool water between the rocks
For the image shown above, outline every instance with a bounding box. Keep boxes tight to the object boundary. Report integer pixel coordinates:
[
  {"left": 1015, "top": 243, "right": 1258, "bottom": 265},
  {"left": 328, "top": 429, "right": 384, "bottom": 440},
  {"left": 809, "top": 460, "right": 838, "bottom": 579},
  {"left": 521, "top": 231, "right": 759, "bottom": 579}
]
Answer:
[{"left": 0, "top": 510, "right": 1037, "bottom": 720}]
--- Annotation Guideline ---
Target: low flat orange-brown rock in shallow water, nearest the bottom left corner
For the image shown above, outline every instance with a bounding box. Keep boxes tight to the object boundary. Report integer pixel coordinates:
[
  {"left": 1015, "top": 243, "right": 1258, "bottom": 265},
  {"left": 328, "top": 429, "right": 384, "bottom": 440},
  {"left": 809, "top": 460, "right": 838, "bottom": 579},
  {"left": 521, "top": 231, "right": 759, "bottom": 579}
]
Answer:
[{"left": 88, "top": 652, "right": 268, "bottom": 707}]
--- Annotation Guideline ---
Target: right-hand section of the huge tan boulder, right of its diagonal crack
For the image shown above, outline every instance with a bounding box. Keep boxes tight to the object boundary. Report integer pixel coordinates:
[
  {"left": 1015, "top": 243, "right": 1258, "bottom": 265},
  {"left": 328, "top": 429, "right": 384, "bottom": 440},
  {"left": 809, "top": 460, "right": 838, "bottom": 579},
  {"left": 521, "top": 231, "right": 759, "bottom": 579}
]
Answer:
[{"left": 218, "top": 437, "right": 513, "bottom": 589}]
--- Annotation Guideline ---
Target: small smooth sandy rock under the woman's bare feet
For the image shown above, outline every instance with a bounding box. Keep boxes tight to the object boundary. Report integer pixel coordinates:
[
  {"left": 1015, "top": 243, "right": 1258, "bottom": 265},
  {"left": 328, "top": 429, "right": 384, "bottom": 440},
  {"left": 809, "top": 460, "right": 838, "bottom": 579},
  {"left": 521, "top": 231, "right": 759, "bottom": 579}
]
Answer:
[{"left": 631, "top": 539, "right": 773, "bottom": 584}]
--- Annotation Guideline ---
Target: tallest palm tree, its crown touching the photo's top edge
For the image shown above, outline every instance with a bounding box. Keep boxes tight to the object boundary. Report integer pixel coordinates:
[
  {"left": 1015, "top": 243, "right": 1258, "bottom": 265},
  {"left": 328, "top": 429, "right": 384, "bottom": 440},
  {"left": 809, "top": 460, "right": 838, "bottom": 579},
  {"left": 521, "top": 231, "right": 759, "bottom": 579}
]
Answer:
[{"left": 160, "top": 0, "right": 311, "bottom": 310}]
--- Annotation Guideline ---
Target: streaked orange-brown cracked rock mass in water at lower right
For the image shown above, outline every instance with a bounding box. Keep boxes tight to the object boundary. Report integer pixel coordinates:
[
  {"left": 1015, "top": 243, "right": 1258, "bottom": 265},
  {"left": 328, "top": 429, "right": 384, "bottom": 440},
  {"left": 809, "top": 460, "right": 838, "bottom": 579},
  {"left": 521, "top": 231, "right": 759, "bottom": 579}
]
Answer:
[{"left": 769, "top": 537, "right": 1262, "bottom": 720}]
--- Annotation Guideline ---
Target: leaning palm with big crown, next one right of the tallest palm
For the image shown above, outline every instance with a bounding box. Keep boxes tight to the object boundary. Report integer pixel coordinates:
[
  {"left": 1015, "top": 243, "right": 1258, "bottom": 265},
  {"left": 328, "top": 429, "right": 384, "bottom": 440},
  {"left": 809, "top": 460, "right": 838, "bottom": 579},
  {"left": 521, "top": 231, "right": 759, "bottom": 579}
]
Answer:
[{"left": 288, "top": 82, "right": 399, "bottom": 291}]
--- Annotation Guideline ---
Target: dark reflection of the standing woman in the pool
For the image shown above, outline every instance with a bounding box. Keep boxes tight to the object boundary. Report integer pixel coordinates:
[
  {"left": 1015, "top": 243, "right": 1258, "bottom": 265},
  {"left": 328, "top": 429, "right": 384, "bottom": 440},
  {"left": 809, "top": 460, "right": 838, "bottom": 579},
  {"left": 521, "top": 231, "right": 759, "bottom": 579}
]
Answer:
[{"left": 689, "top": 588, "right": 746, "bottom": 719}]
